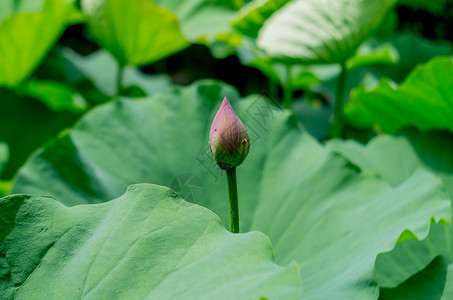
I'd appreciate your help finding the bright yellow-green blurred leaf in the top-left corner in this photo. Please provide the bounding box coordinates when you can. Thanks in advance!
[0,0,74,87]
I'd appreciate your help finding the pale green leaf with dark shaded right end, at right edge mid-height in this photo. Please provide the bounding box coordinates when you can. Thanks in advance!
[328,129,453,193]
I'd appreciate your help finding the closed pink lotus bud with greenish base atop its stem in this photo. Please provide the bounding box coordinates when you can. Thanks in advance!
[209,97,250,170]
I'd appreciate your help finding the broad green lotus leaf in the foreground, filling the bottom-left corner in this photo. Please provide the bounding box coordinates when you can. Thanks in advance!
[0,184,301,299]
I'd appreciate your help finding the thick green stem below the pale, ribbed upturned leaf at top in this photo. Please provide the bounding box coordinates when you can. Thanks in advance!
[330,61,348,138]
